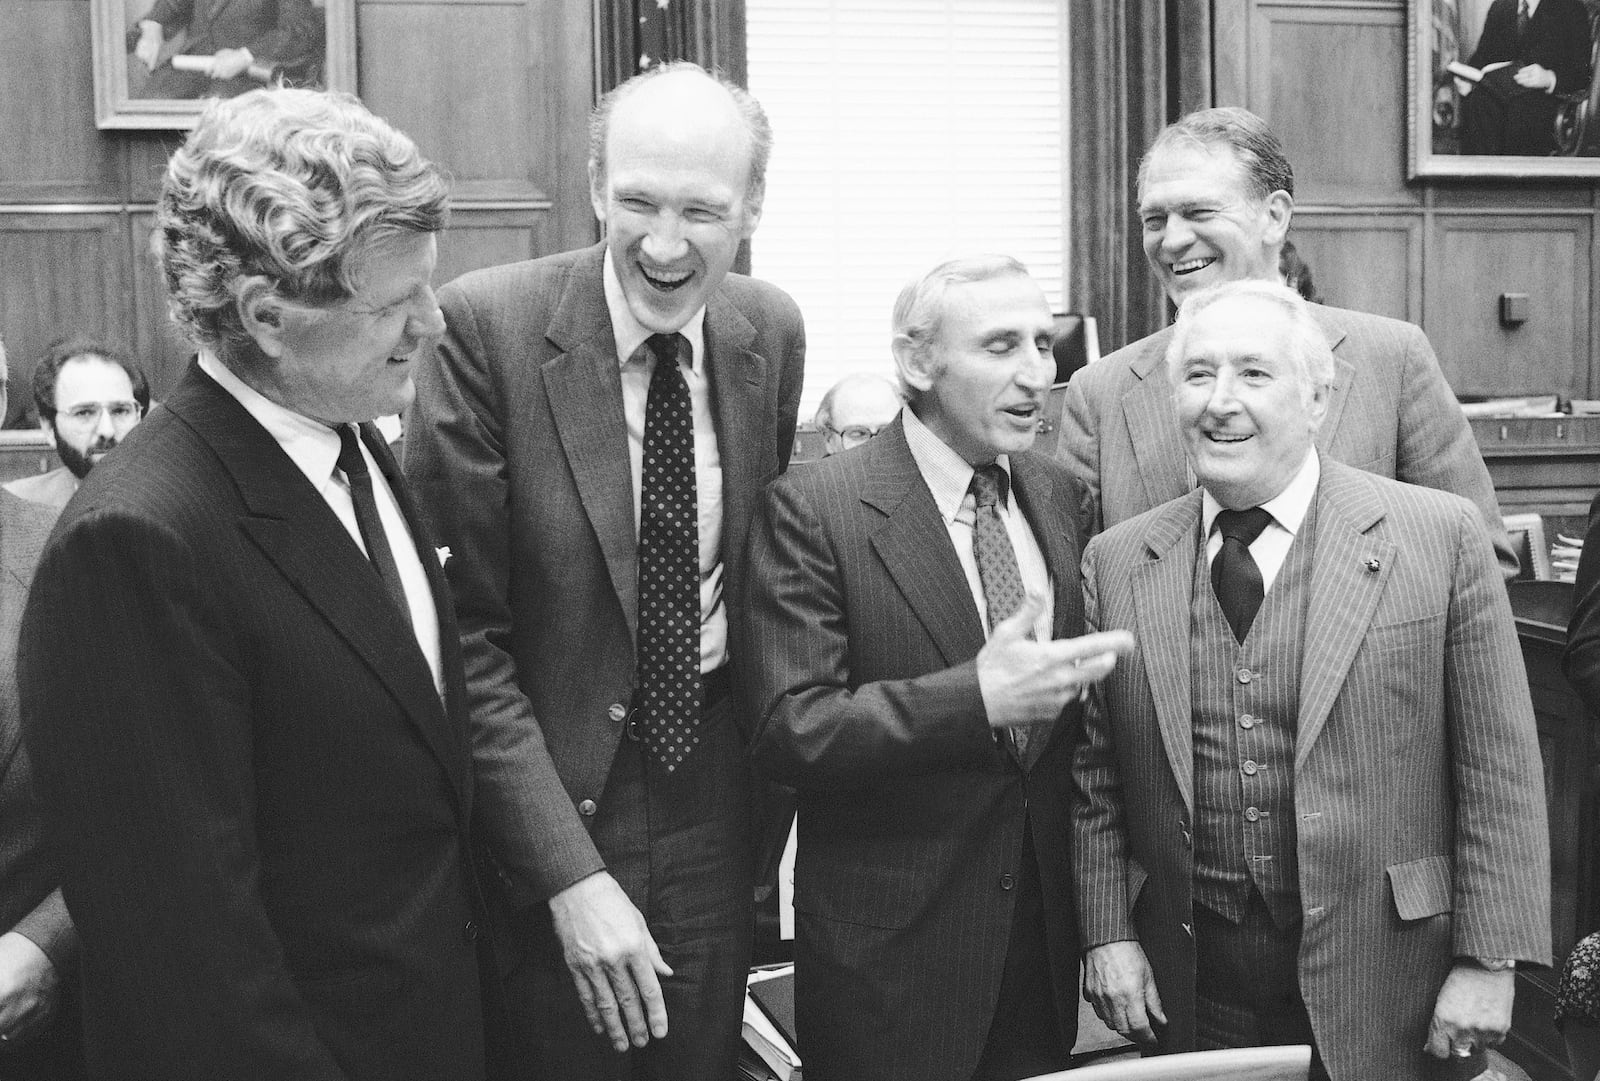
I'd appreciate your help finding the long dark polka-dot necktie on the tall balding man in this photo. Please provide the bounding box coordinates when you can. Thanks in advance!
[638,334,701,772]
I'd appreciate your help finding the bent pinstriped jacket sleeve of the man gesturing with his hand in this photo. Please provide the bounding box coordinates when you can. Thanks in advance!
[739,478,1002,788]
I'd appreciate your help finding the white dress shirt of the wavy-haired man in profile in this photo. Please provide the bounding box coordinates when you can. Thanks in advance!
[200,350,445,696]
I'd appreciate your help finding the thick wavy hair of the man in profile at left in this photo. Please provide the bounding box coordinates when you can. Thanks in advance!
[155,88,450,358]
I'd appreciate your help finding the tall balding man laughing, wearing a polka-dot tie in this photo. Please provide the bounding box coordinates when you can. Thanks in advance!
[406,64,805,1081]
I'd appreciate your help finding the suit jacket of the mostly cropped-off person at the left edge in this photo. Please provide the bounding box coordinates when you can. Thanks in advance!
[0,491,77,979]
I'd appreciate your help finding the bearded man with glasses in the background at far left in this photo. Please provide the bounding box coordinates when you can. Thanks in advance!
[5,337,150,510]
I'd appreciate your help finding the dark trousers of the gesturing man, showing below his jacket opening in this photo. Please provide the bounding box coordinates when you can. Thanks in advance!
[966,825,1077,1081]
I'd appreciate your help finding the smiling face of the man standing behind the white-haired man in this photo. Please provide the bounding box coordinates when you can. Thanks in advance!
[1139,142,1293,305]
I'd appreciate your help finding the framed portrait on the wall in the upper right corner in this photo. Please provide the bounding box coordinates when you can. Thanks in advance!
[1408,0,1600,178]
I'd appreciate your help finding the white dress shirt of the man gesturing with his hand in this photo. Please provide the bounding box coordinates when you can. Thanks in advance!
[901,406,1056,641]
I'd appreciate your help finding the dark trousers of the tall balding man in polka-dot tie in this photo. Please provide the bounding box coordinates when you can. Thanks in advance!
[506,687,754,1081]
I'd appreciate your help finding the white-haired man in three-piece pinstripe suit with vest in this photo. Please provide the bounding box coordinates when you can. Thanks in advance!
[1074,281,1550,1081]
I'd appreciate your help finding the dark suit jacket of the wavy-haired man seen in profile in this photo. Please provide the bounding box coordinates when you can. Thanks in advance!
[19,366,483,1081]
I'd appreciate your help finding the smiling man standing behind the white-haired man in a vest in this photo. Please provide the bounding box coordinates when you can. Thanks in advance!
[1058,109,1517,576]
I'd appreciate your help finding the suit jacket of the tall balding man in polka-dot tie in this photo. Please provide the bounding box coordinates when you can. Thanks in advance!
[406,246,805,903]
